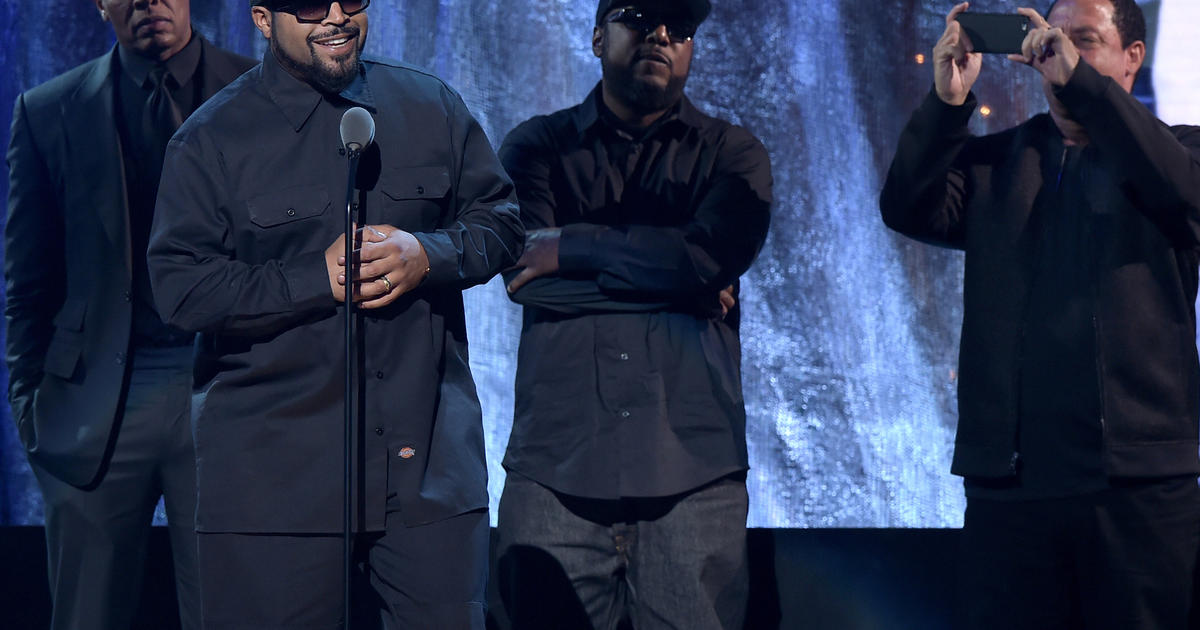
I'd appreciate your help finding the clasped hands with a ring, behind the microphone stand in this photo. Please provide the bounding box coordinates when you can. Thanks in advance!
[325,224,430,308]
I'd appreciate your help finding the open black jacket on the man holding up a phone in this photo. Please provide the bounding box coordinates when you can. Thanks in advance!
[880,61,1200,478]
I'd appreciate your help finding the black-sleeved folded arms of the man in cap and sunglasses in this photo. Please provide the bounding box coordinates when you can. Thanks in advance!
[500,120,772,312]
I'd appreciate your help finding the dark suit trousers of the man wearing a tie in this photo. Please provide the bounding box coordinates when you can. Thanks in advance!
[34,347,199,630]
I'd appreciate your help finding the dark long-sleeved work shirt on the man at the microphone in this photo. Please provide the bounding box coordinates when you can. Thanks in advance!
[149,52,523,533]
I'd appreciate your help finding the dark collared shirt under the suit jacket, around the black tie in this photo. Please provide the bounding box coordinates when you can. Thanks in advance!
[116,35,202,347]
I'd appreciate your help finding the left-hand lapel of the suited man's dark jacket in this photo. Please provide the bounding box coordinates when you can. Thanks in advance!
[62,47,131,268]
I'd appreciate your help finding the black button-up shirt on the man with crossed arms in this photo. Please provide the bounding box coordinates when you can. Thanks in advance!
[500,88,772,499]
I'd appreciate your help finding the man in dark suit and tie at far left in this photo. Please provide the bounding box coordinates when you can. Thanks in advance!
[5,0,253,630]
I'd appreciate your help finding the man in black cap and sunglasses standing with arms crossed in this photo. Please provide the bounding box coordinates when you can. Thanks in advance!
[498,0,772,629]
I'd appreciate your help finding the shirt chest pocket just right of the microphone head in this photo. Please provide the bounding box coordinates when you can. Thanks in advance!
[366,166,450,232]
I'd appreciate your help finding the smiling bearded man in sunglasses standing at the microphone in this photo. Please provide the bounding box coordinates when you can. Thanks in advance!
[149,0,522,629]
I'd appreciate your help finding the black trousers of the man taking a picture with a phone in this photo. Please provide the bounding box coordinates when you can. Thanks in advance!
[955,478,1200,630]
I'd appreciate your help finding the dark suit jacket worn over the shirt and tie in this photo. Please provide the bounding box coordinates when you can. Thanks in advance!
[4,34,256,486]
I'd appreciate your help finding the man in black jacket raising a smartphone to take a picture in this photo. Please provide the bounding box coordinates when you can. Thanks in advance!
[880,0,1200,630]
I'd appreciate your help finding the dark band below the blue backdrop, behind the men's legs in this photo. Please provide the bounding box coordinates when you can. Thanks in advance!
[0,527,959,630]
